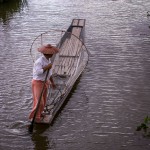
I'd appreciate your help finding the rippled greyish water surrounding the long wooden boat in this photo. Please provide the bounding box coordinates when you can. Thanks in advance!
[0,0,150,150]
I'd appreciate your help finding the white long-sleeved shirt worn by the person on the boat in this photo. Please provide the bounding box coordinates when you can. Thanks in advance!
[33,55,52,81]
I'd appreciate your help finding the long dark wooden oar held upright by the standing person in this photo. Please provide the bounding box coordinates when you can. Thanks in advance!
[28,69,49,133]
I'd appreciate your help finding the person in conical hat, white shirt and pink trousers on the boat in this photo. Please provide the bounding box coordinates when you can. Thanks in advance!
[29,44,59,122]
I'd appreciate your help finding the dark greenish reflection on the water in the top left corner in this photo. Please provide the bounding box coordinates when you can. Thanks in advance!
[0,0,28,24]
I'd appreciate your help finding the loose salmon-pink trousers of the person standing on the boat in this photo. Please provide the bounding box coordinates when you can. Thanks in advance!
[29,80,49,121]
